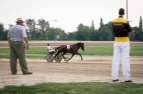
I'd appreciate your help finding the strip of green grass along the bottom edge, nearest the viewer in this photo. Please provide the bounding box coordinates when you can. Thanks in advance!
[0,82,143,94]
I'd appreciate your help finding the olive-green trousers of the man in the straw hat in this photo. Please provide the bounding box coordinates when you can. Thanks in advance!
[10,41,28,74]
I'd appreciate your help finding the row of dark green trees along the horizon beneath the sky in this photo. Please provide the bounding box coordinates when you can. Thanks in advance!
[0,16,143,41]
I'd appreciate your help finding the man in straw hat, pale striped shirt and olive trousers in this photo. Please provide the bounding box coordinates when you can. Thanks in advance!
[7,18,32,75]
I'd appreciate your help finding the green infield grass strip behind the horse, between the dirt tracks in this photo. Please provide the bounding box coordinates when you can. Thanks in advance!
[0,46,143,59]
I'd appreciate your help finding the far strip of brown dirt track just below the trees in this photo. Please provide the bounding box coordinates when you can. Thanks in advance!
[0,41,143,47]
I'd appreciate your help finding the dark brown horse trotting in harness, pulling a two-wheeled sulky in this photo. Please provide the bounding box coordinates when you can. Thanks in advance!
[54,42,84,61]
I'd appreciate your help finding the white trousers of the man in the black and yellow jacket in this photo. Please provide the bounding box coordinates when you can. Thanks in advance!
[111,42,130,81]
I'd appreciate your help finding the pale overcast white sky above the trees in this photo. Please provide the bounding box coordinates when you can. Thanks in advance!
[0,0,143,32]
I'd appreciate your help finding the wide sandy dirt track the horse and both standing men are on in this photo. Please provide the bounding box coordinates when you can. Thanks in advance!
[0,42,143,88]
